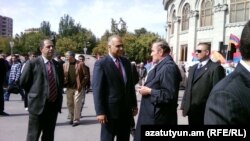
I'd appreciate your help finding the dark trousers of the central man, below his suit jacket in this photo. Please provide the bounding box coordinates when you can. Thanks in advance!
[101,119,131,141]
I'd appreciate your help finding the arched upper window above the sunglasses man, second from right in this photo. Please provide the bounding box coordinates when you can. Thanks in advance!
[200,0,214,27]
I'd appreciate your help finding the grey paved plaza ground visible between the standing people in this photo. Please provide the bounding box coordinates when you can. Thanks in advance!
[0,90,187,141]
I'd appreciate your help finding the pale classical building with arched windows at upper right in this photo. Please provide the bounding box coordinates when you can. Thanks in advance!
[163,0,250,62]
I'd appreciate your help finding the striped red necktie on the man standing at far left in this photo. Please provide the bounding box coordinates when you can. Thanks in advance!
[47,61,57,102]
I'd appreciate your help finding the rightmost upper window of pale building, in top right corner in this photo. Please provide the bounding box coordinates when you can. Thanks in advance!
[230,0,250,23]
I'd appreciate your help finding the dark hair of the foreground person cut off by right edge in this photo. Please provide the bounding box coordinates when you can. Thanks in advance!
[240,20,250,60]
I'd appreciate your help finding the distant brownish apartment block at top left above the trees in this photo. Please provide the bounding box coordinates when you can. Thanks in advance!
[0,15,13,37]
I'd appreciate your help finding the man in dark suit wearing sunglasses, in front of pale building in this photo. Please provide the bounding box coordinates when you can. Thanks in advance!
[181,43,225,125]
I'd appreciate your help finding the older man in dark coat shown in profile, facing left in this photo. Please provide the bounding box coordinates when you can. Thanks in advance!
[135,40,181,141]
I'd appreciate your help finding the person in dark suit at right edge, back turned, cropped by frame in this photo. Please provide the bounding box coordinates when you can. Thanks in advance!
[204,21,250,125]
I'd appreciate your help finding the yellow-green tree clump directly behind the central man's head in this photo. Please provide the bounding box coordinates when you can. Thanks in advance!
[93,19,160,63]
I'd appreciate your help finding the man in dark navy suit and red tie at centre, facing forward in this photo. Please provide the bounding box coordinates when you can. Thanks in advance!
[93,35,137,141]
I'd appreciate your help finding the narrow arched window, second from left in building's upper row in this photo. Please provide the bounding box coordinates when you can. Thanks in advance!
[181,3,190,31]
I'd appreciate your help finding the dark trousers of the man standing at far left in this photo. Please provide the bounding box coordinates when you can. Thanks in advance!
[27,102,58,141]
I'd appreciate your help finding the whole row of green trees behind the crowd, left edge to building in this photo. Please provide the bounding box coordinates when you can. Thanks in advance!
[0,14,160,63]
